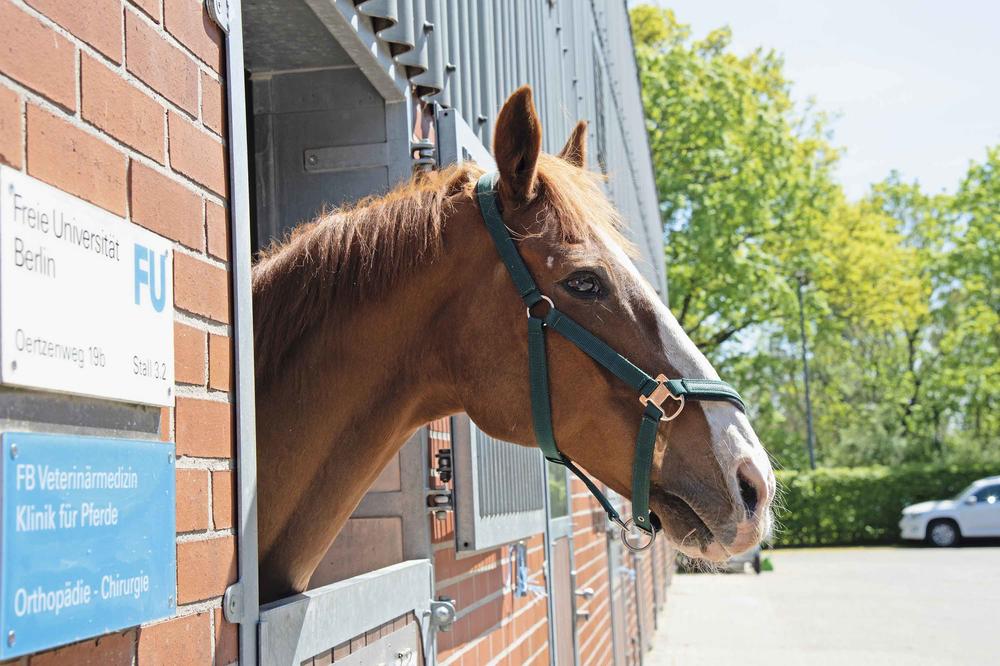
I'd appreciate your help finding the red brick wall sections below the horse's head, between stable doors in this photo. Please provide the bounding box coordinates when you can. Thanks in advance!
[429,419,669,666]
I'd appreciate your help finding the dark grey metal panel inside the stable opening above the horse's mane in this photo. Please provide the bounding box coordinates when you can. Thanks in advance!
[252,68,410,245]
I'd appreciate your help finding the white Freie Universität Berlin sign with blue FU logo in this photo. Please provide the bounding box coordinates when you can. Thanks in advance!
[0,166,174,406]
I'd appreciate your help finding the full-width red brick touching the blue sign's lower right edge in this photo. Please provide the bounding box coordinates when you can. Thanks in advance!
[177,536,236,600]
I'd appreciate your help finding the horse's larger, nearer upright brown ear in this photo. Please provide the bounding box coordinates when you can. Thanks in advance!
[493,86,542,205]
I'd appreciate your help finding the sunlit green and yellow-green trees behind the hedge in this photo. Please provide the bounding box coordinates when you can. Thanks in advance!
[631,5,1000,468]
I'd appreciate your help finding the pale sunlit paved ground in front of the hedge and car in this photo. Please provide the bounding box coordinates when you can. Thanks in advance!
[645,546,1000,666]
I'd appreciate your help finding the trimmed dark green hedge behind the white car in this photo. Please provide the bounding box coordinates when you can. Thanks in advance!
[774,464,1000,547]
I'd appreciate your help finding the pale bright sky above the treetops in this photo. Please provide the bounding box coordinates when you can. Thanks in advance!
[648,0,1000,199]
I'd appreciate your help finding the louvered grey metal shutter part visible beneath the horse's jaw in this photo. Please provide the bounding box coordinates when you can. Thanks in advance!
[451,416,546,551]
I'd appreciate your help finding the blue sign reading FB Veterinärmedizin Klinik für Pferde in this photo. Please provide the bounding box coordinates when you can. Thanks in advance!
[0,432,177,659]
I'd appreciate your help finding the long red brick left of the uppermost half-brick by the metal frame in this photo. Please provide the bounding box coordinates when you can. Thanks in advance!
[125,11,198,116]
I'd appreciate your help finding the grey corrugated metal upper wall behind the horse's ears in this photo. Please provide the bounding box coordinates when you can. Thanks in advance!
[344,0,665,295]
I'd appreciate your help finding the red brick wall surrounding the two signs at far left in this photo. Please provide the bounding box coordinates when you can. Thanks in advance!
[0,0,237,666]
